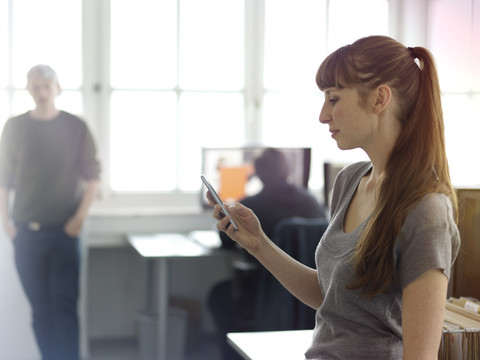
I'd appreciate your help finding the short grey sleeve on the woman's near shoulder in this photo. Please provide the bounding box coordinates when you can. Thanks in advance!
[395,194,460,288]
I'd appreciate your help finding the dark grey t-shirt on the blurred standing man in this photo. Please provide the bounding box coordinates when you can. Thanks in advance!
[0,111,100,224]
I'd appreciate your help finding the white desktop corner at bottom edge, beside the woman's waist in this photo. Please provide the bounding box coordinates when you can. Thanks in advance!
[227,330,313,360]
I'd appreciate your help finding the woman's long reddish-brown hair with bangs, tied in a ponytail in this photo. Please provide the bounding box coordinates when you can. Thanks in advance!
[316,36,458,296]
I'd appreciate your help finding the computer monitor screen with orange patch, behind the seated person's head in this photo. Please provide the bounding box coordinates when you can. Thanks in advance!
[201,146,311,207]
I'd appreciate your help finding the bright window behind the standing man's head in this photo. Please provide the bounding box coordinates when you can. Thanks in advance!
[0,0,83,126]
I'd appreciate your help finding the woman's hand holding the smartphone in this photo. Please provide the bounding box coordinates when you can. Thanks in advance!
[207,191,268,255]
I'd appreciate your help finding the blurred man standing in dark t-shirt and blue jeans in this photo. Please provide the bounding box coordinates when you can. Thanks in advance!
[0,65,100,360]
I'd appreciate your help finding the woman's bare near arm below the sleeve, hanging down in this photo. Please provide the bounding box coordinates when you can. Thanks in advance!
[402,269,448,360]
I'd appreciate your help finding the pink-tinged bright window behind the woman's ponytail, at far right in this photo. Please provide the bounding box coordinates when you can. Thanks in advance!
[428,0,480,186]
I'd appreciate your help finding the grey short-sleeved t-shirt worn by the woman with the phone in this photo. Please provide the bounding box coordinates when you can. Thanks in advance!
[305,162,460,360]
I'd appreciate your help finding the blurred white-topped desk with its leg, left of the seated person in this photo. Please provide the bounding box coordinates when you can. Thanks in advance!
[128,232,232,360]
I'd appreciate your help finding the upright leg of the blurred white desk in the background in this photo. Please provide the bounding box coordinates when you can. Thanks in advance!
[157,258,170,360]
